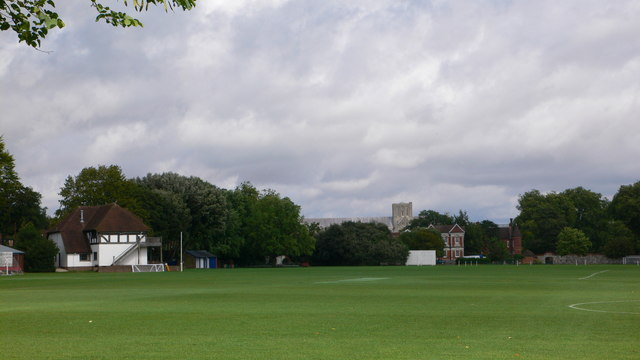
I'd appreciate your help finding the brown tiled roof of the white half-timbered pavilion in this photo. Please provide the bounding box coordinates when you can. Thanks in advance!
[47,203,149,254]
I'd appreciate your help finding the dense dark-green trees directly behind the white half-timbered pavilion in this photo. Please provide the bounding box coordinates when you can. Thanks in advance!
[56,165,315,264]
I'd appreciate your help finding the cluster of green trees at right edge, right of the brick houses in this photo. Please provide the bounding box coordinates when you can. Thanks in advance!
[516,187,640,258]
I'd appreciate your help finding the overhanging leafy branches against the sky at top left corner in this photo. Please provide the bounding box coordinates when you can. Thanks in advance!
[0,0,196,48]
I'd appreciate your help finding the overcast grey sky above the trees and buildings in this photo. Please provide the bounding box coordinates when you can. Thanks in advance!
[0,0,640,223]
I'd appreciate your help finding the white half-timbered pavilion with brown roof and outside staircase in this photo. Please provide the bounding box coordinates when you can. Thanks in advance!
[47,204,162,270]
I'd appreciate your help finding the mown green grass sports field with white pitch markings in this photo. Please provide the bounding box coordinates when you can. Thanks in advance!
[0,265,640,359]
